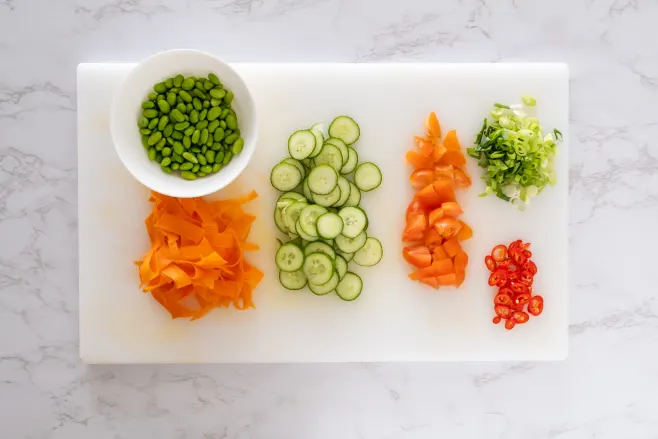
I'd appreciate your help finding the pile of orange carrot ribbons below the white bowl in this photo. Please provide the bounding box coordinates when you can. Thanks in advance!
[136,192,263,320]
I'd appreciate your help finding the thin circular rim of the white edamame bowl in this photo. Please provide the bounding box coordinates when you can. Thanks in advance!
[109,49,258,198]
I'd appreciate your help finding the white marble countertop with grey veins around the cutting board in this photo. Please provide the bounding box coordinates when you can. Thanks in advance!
[0,0,658,439]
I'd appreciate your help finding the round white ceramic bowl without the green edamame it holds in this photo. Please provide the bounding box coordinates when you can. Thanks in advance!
[110,50,258,198]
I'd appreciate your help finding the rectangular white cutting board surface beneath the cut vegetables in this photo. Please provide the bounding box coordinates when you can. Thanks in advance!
[78,64,568,363]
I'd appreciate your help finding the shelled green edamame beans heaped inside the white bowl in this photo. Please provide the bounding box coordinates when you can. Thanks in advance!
[137,73,244,180]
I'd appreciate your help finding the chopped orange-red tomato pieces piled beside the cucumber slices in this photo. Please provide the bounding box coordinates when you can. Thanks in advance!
[402,113,473,288]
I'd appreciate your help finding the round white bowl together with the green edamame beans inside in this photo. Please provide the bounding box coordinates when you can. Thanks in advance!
[110,50,258,198]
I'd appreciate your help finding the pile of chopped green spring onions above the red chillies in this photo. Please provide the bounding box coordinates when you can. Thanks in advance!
[467,95,562,210]
